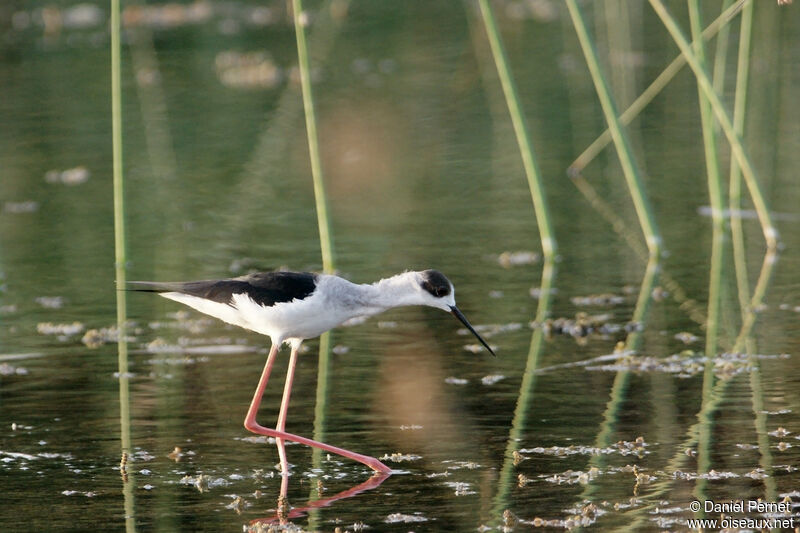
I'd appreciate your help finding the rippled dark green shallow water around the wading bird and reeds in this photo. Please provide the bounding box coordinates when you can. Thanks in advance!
[0,1,800,531]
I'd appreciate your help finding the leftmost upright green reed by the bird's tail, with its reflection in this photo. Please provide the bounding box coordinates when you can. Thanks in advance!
[111,0,136,532]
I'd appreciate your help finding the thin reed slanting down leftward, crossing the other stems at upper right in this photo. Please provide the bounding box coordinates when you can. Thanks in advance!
[569,2,741,172]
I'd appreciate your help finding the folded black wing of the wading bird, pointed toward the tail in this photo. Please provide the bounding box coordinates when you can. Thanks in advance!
[129,272,317,307]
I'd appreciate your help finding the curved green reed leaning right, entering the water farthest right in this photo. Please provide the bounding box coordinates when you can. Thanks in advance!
[650,0,778,249]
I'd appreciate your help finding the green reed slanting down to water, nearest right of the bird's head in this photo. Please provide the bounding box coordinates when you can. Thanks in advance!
[478,0,557,258]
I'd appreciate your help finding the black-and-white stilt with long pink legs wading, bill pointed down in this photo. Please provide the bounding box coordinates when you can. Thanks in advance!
[128,270,495,475]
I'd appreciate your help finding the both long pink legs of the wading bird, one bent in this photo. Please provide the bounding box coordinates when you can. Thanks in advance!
[244,345,392,474]
